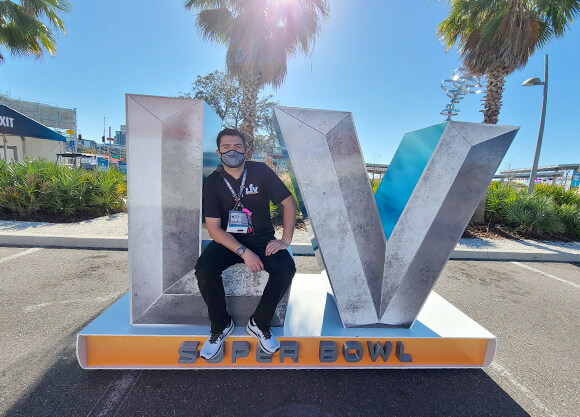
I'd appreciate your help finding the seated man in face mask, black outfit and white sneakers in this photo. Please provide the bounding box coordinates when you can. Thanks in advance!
[195,129,296,359]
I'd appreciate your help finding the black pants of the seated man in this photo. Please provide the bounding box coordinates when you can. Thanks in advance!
[195,236,296,333]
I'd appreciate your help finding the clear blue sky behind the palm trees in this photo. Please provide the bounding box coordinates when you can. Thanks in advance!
[0,0,580,169]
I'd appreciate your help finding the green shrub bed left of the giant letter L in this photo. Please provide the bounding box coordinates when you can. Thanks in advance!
[0,158,127,220]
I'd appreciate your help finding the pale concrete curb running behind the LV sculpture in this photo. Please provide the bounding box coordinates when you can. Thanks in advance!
[0,233,580,262]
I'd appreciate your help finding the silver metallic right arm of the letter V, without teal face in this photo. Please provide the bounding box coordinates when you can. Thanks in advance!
[381,122,517,327]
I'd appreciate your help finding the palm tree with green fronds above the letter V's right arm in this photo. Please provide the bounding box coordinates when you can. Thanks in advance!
[437,0,580,124]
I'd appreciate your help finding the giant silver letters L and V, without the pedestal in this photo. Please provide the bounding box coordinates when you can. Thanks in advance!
[127,95,517,327]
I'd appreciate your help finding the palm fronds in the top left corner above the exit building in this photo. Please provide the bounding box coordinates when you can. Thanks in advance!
[0,0,71,64]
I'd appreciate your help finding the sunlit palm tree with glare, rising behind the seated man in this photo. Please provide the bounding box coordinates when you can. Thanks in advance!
[185,0,329,155]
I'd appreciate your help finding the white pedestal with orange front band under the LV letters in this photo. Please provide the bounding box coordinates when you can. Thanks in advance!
[77,274,496,369]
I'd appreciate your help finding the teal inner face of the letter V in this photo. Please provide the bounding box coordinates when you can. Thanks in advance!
[375,122,447,240]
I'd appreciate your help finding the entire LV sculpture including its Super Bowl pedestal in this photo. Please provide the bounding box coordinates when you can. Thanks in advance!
[77,94,517,369]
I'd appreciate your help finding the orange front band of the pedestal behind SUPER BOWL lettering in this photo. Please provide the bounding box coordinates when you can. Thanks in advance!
[79,335,489,369]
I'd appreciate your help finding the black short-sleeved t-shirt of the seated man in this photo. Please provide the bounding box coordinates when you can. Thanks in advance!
[203,161,291,237]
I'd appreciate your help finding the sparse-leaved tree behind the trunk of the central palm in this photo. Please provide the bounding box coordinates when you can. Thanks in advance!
[180,71,278,155]
